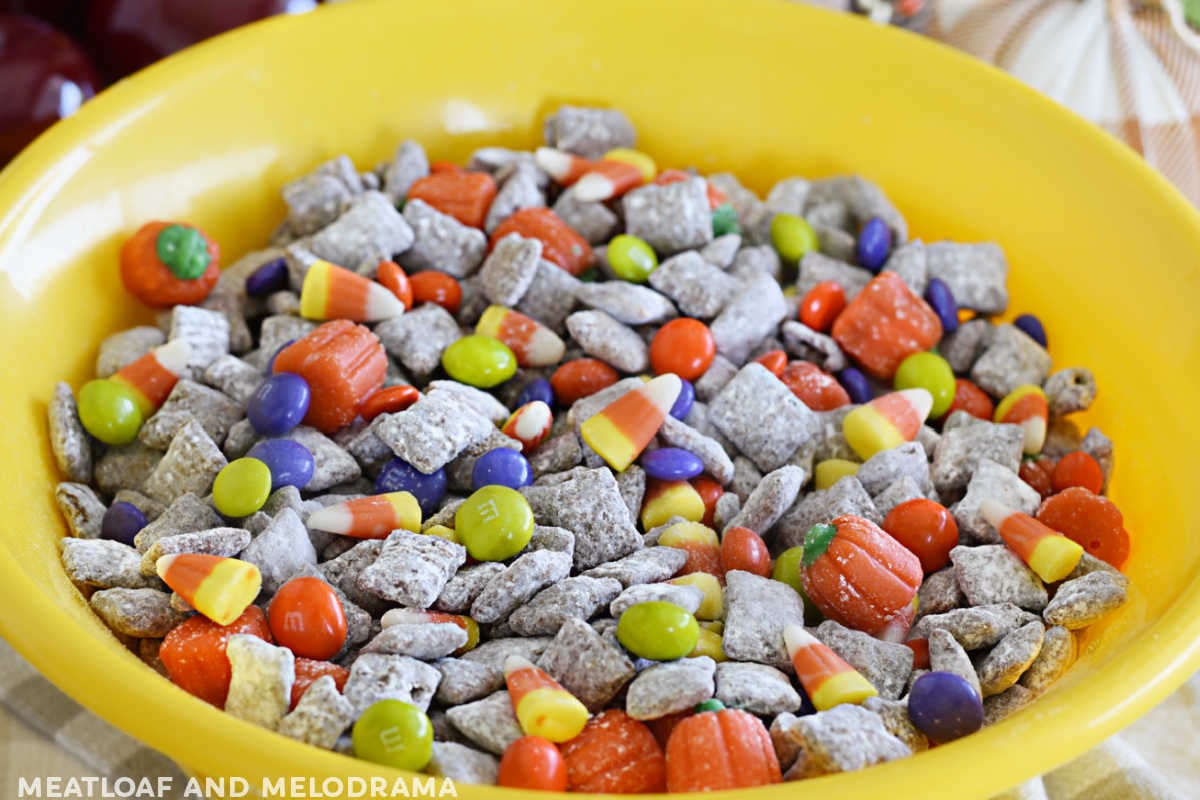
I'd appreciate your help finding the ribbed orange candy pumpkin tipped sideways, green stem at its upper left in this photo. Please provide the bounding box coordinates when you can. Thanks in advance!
[800,515,922,638]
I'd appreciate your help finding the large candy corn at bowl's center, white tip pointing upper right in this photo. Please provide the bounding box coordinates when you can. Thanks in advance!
[580,373,686,472]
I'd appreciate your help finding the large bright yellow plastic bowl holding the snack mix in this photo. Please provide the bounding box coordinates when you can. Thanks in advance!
[0,0,1200,800]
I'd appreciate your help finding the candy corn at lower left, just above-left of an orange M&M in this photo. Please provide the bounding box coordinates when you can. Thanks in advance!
[155,553,263,625]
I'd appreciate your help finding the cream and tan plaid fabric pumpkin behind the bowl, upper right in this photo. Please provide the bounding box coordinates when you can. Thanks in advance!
[929,0,1200,205]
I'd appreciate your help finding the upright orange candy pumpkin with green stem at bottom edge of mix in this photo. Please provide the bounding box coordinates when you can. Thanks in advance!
[667,700,784,792]
